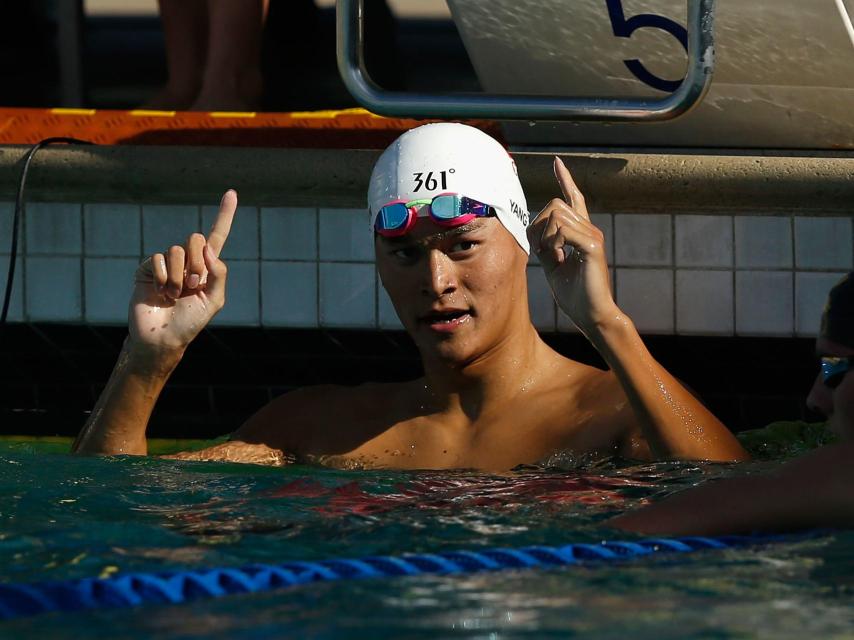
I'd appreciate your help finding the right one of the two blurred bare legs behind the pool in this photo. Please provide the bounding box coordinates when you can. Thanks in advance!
[192,0,267,111]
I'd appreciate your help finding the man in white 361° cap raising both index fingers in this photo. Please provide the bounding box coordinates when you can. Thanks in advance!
[73,123,747,470]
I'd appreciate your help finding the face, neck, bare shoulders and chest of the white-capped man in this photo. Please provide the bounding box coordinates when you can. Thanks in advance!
[227,218,649,469]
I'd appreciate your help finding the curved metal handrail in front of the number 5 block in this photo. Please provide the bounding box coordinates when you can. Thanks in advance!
[336,0,715,122]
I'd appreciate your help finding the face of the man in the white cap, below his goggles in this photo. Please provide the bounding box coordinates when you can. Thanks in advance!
[375,218,530,366]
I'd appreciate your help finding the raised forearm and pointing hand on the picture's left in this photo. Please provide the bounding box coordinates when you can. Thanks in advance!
[72,190,237,455]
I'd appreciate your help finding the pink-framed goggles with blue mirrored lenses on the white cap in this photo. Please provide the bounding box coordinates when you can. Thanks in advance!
[374,193,495,238]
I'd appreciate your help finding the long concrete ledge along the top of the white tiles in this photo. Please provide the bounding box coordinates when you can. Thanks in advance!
[0,146,854,216]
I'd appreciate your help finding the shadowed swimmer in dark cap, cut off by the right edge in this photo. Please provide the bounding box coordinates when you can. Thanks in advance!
[609,272,854,535]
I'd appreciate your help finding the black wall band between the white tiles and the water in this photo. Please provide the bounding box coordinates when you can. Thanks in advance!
[0,324,818,438]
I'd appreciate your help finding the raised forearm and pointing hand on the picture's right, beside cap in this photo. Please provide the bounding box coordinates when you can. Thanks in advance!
[528,158,748,460]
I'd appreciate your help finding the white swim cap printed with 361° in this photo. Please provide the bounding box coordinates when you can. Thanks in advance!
[368,122,530,253]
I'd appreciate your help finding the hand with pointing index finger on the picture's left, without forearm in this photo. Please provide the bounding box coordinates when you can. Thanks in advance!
[128,189,237,351]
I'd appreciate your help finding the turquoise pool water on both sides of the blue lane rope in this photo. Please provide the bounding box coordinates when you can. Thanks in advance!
[0,441,854,639]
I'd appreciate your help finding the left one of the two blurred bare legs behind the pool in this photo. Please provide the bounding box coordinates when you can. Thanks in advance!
[144,0,209,110]
